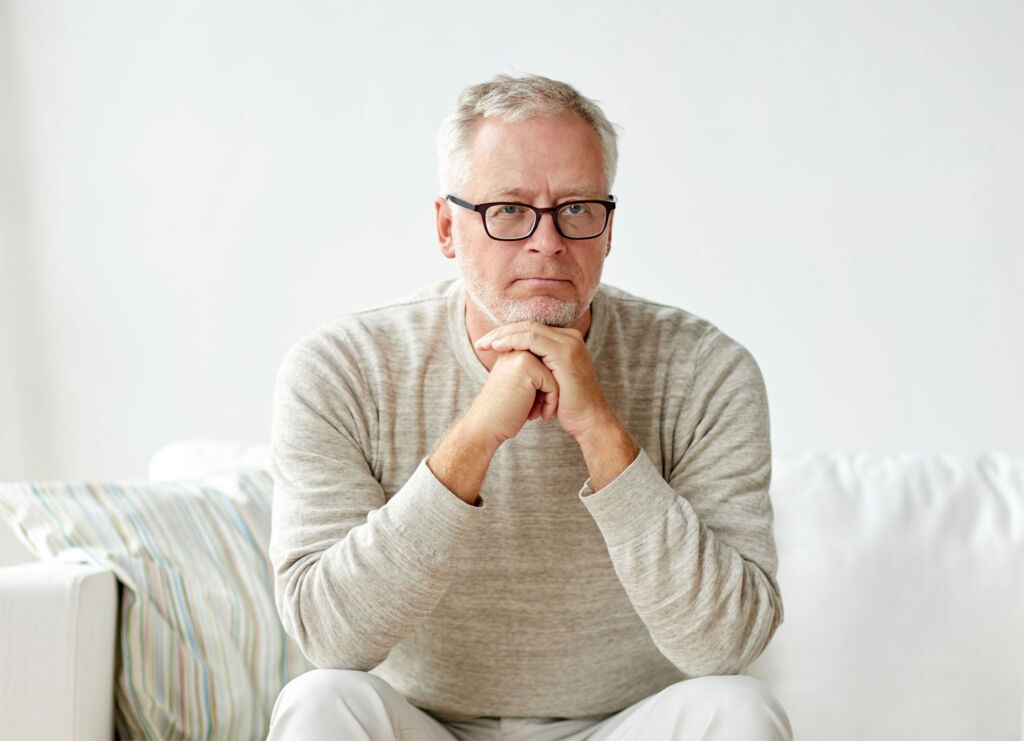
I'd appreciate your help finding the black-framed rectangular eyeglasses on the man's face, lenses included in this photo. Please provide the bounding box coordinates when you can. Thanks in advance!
[444,193,615,242]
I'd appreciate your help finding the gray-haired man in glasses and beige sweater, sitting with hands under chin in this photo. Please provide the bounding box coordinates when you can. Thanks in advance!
[270,76,790,739]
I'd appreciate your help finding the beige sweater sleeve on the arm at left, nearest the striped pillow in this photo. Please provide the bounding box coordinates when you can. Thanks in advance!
[270,337,480,670]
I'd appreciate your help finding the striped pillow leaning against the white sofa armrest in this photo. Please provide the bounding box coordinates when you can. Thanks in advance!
[0,471,307,739]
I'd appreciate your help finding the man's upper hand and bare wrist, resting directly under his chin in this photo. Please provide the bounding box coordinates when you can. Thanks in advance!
[476,321,640,489]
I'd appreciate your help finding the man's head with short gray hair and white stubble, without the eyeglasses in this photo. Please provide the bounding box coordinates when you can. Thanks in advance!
[436,76,616,332]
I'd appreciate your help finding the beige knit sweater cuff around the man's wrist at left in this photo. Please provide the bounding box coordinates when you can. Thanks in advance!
[377,460,484,555]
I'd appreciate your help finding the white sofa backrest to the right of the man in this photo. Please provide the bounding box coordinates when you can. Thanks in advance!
[751,453,1024,741]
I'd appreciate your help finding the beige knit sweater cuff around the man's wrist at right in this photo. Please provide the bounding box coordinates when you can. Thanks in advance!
[580,449,679,546]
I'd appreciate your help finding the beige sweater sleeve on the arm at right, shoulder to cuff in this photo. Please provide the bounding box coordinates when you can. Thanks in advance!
[581,328,782,677]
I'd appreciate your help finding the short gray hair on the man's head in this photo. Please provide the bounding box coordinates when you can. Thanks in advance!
[437,75,618,193]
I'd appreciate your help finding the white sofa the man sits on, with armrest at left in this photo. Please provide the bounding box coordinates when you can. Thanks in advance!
[0,443,1024,741]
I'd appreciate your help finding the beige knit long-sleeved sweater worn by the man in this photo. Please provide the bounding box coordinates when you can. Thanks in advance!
[270,280,782,720]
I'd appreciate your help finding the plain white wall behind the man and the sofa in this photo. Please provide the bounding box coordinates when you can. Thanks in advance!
[0,0,1024,479]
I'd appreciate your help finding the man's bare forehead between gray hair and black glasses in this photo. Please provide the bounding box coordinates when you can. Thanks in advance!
[469,114,607,198]
